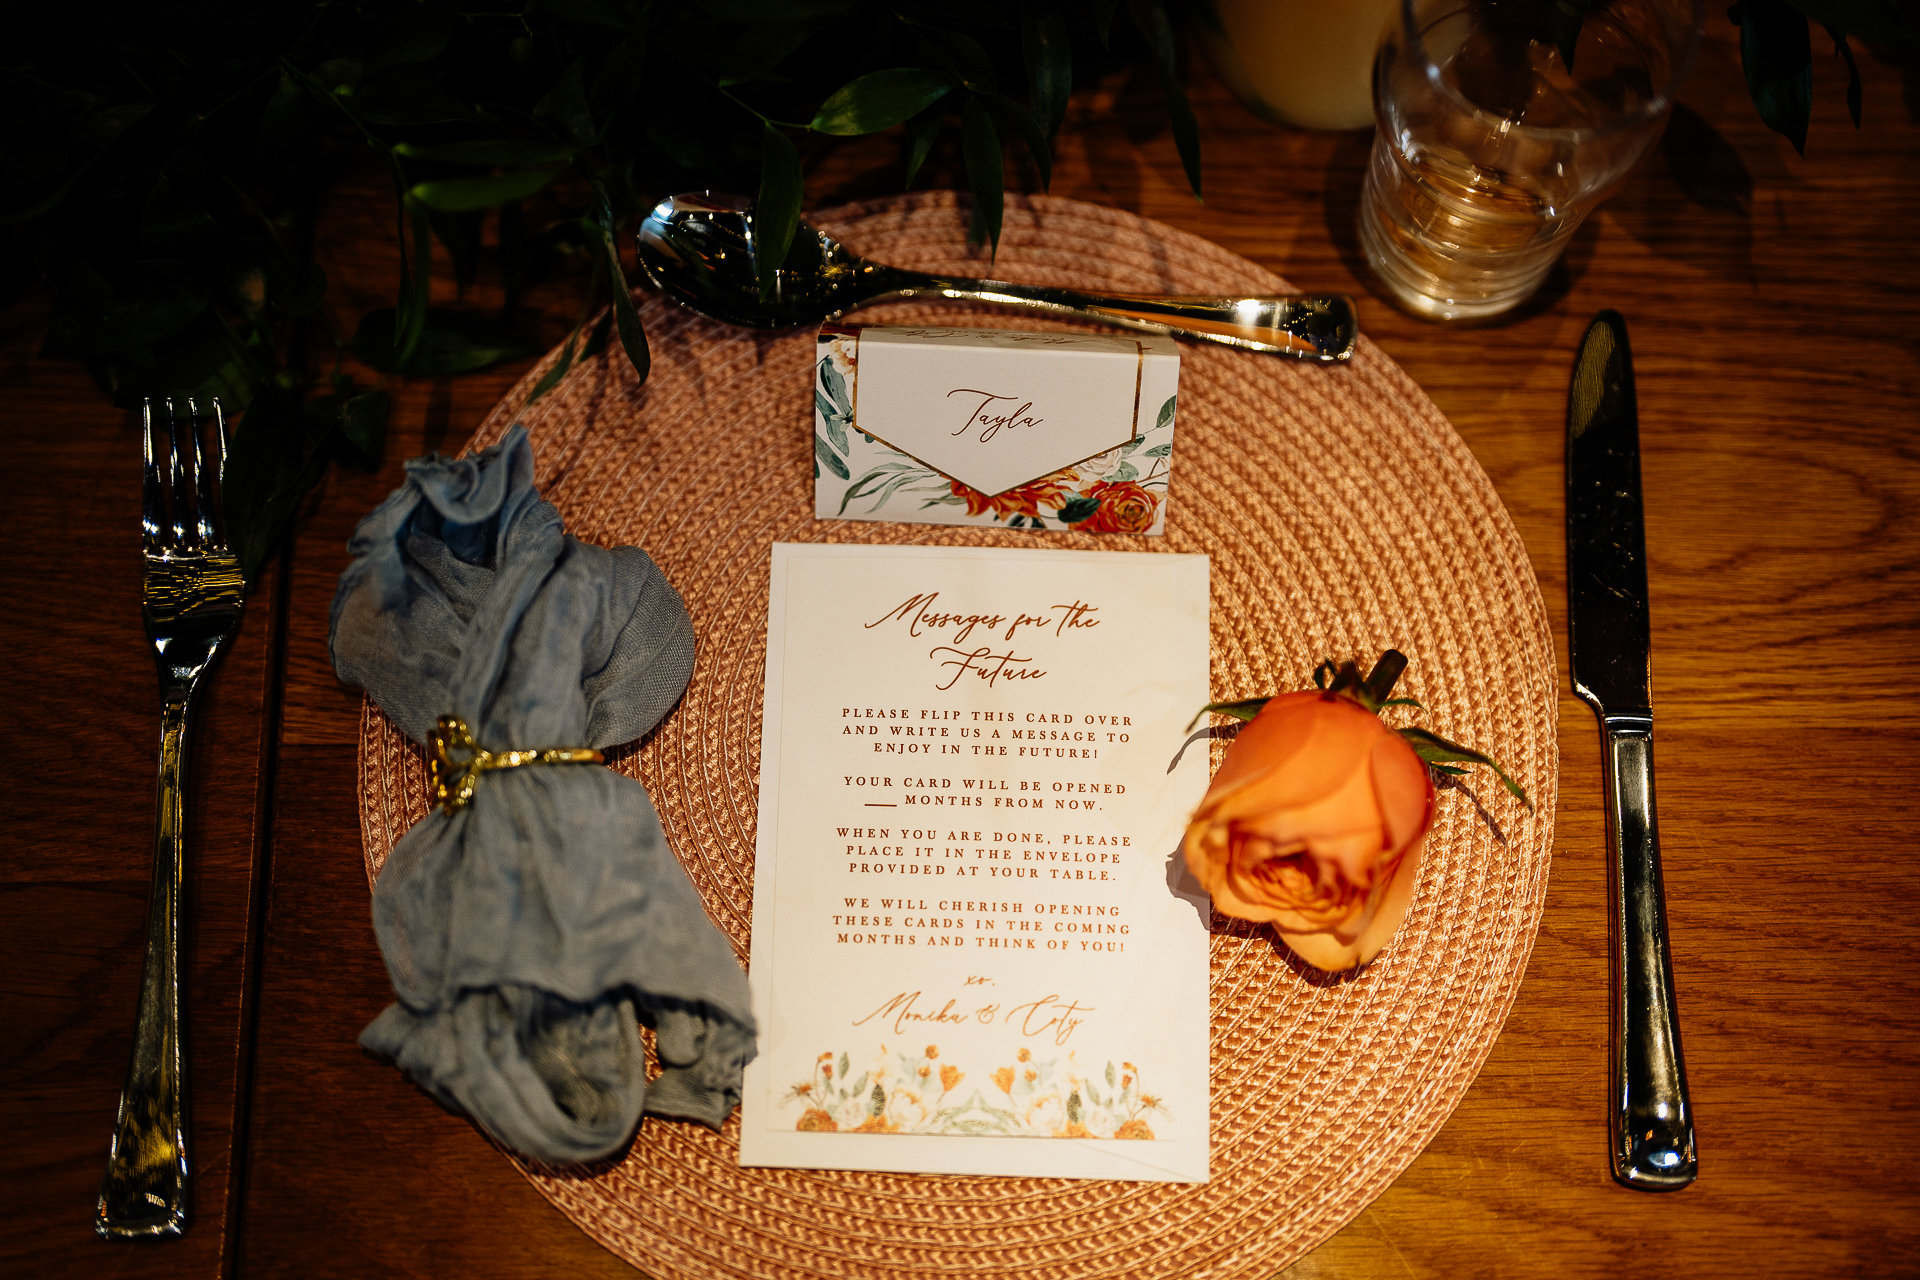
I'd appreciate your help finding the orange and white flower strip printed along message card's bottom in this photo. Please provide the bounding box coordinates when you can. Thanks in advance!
[781,1044,1167,1142]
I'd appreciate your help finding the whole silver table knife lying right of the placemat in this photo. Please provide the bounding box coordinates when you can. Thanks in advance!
[1567,311,1699,1192]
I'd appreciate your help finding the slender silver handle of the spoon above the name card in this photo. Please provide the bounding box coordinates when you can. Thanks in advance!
[868,271,1359,363]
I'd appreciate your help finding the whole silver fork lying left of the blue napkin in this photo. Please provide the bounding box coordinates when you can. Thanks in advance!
[94,399,242,1240]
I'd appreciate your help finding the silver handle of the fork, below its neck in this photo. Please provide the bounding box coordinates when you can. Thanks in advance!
[94,699,188,1240]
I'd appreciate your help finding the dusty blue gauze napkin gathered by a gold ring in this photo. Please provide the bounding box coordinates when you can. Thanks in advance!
[330,426,755,1161]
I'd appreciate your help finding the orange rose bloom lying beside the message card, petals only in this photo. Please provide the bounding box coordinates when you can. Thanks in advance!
[1183,691,1434,971]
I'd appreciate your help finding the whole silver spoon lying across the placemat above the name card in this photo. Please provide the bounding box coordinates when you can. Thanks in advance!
[639,192,1359,361]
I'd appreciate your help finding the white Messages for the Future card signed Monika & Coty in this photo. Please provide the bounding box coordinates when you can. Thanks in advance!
[741,545,1208,1182]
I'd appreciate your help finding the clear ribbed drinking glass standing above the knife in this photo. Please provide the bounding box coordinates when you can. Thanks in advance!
[1359,0,1701,320]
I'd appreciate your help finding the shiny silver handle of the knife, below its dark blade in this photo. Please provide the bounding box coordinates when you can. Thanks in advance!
[1601,716,1699,1192]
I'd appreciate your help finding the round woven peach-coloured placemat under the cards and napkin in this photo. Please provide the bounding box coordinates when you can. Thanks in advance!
[361,194,1557,1280]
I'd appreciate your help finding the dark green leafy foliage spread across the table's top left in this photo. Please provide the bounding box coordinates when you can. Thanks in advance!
[0,0,1200,574]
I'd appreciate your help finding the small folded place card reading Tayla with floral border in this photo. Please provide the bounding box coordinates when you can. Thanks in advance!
[814,324,1181,535]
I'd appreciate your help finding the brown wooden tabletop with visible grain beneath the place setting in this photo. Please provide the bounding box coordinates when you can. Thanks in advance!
[0,15,1920,1278]
